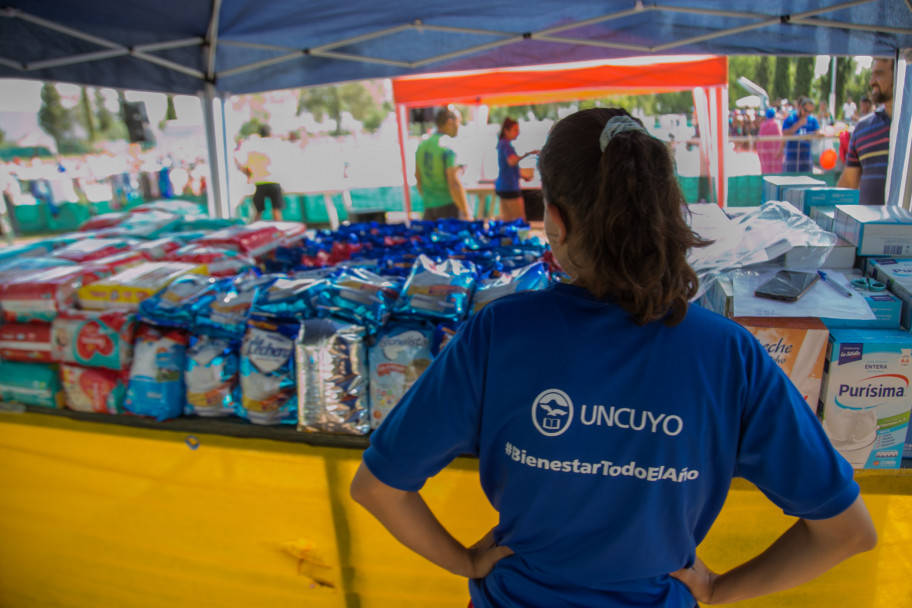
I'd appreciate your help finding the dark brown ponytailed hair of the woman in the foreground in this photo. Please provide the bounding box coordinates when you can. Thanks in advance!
[538,108,709,325]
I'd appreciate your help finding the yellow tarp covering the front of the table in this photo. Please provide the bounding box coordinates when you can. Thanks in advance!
[0,413,912,608]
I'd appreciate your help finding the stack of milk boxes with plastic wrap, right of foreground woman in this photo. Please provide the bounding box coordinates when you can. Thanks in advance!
[697,200,912,469]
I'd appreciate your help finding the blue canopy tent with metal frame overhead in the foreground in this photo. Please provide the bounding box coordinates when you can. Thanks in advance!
[0,0,912,215]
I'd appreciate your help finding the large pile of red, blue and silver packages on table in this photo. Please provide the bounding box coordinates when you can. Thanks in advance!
[0,216,560,435]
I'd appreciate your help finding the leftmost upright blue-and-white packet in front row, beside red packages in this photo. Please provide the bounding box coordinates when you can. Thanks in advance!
[124,324,187,420]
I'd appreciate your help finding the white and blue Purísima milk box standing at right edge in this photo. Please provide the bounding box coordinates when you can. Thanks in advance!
[817,329,912,469]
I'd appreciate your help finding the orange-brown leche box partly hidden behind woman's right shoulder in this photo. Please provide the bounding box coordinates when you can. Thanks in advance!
[735,317,830,410]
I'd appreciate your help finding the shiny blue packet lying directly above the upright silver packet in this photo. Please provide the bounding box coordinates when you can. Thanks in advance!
[316,268,402,333]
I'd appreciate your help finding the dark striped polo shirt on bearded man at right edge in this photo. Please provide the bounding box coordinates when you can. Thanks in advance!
[846,110,890,205]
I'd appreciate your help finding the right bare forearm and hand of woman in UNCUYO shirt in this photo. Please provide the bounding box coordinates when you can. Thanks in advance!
[671,496,877,604]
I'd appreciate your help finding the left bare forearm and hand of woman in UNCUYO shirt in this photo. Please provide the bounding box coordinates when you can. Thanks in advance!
[351,462,513,578]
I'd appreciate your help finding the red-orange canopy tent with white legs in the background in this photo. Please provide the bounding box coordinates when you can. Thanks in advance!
[393,56,728,211]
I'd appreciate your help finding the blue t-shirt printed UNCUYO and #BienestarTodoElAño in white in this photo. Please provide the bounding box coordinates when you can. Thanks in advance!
[364,284,858,608]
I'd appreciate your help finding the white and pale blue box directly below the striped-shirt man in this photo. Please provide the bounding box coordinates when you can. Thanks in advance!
[834,205,912,257]
